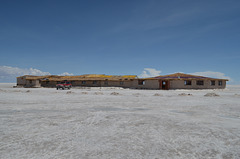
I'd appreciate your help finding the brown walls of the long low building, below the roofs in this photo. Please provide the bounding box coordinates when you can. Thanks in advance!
[17,76,226,89]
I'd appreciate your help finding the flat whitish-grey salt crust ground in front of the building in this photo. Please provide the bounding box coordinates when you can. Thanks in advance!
[0,84,240,159]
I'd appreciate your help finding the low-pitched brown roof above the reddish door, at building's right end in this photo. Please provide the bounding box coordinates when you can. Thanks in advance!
[144,73,228,81]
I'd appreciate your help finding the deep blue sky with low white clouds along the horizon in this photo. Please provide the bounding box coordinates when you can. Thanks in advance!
[0,0,240,84]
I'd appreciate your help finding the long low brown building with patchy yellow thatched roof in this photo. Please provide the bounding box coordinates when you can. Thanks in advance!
[17,73,228,90]
